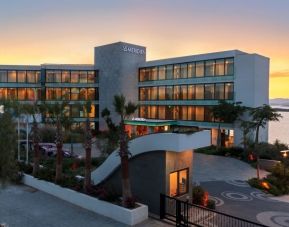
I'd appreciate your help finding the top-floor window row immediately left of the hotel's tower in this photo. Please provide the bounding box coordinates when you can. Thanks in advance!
[46,70,98,83]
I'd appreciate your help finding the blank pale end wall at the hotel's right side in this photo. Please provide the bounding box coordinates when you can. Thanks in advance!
[234,54,269,145]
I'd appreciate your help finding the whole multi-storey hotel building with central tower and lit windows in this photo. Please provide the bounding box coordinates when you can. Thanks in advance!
[0,42,269,145]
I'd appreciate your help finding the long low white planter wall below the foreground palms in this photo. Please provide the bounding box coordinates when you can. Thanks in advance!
[23,174,148,226]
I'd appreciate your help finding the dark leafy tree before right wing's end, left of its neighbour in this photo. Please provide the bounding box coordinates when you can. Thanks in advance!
[212,100,246,148]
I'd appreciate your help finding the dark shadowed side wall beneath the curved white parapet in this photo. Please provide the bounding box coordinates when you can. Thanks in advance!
[104,151,166,214]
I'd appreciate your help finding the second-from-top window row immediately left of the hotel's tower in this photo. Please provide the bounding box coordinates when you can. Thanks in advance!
[46,88,98,101]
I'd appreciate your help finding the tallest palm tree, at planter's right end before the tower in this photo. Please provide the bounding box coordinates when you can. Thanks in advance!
[113,95,137,206]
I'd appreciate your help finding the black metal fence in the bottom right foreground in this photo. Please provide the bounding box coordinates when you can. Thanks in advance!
[160,194,268,227]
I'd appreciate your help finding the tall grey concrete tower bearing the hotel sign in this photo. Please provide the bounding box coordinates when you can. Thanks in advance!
[94,42,146,130]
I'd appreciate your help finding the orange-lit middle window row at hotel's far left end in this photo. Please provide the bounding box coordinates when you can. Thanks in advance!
[0,88,41,101]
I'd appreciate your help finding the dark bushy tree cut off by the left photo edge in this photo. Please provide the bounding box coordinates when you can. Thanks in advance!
[0,109,18,186]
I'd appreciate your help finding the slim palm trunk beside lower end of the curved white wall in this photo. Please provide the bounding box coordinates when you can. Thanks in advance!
[83,102,92,193]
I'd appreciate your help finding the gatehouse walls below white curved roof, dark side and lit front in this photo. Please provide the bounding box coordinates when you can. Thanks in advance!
[104,150,193,214]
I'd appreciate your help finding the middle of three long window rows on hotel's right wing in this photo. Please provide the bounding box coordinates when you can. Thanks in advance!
[139,83,234,101]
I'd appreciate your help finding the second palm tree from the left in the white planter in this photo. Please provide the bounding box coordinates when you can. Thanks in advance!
[42,101,71,183]
